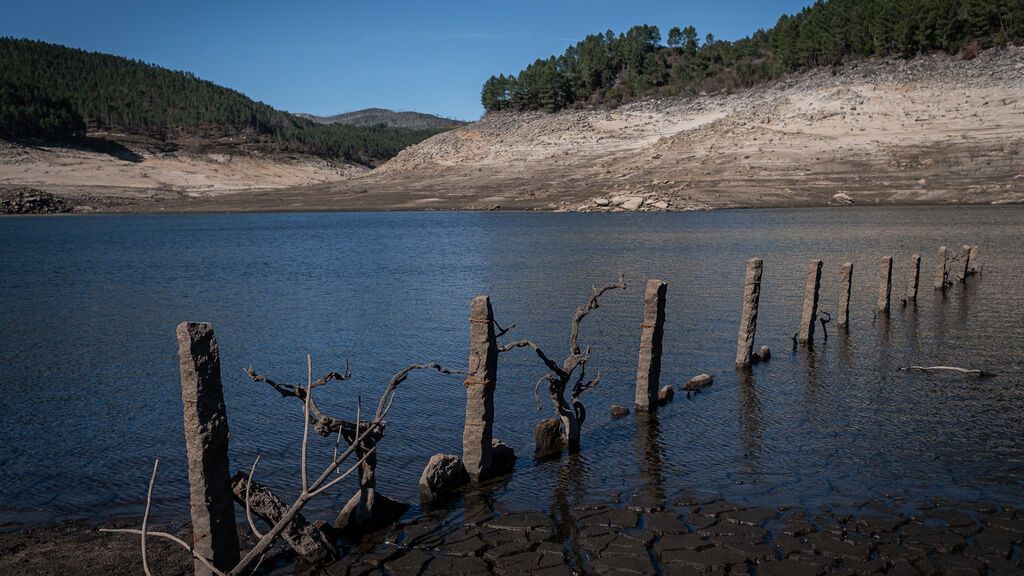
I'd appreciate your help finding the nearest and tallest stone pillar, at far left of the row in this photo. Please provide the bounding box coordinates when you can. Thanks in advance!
[177,322,239,576]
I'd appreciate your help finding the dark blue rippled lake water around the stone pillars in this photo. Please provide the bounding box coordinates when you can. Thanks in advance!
[0,207,1024,523]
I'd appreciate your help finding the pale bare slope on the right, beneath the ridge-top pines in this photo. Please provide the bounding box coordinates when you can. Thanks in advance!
[321,44,1024,210]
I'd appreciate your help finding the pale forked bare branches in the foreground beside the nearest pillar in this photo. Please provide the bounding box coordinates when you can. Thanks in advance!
[100,358,464,576]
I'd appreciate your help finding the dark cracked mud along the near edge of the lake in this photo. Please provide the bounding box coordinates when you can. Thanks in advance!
[0,495,1024,576]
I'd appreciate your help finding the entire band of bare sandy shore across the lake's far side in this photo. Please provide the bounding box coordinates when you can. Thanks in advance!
[0,44,1024,210]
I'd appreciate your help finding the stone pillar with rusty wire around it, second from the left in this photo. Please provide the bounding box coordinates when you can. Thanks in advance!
[462,296,498,482]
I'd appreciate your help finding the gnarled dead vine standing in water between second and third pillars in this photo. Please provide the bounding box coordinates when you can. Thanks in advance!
[499,275,626,452]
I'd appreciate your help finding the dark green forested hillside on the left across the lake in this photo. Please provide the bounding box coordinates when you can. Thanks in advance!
[0,38,440,163]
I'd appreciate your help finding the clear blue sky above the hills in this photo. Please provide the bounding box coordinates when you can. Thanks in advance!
[0,0,812,120]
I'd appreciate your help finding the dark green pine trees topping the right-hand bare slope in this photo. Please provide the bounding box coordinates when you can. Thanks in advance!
[481,0,1024,112]
